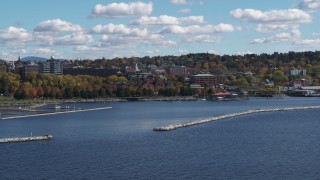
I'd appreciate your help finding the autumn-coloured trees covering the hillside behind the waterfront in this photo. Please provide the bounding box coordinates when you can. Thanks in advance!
[0,51,320,99]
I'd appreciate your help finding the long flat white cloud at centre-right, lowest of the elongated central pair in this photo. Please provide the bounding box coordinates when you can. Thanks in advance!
[161,23,240,34]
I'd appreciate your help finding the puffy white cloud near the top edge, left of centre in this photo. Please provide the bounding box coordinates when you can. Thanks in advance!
[91,2,153,18]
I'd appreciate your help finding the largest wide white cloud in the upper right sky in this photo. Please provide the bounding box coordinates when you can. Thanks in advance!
[230,9,312,23]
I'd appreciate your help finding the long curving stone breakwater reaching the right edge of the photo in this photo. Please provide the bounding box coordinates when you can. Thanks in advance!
[153,106,320,131]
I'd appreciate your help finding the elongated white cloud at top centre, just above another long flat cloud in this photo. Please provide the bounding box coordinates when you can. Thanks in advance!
[131,15,204,25]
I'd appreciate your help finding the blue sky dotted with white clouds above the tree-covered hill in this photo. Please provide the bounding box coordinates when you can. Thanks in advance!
[0,0,320,60]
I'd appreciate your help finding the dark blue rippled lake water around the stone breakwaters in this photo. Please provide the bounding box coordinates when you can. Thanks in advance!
[0,98,320,179]
